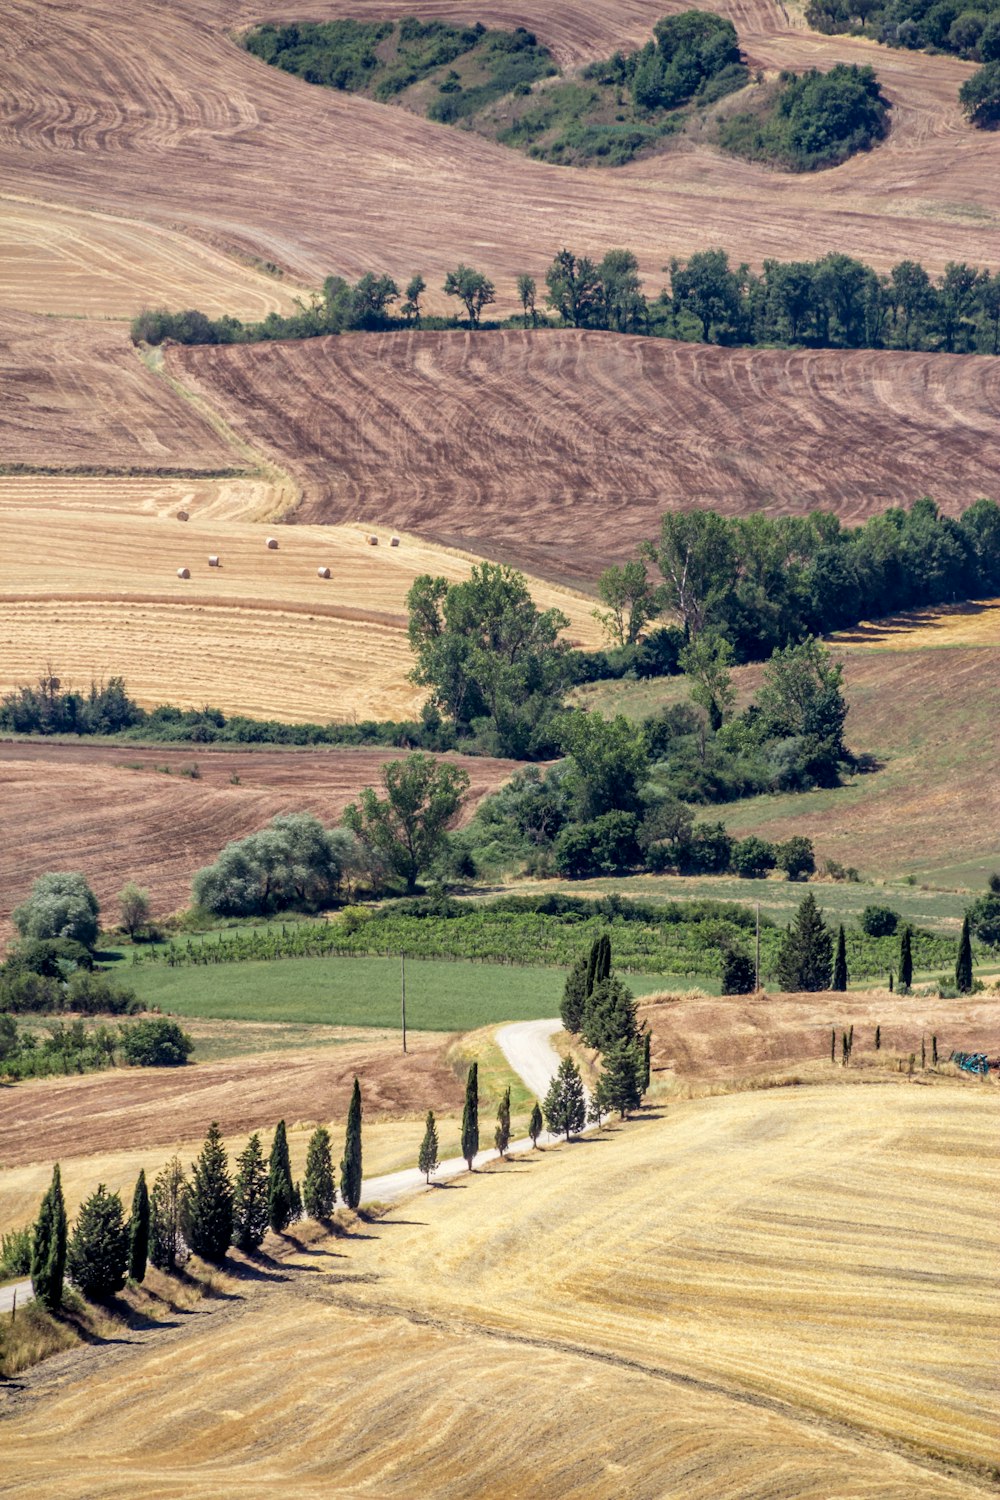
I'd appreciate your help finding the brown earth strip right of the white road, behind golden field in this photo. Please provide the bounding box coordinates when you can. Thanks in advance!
[639,990,1000,1083]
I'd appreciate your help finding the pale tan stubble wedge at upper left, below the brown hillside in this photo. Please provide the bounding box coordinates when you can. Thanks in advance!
[0,195,301,320]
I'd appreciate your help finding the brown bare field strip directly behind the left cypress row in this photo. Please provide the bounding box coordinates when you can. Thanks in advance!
[0,1034,463,1169]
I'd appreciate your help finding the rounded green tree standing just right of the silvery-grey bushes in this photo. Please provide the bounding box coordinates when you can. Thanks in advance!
[343,752,469,891]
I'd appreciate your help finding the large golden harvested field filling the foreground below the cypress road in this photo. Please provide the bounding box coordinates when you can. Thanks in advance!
[3,1085,1000,1500]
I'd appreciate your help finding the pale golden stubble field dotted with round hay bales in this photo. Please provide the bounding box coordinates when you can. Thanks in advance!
[0,504,593,723]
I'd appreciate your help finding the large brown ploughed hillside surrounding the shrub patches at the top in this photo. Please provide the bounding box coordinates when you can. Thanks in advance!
[0,0,1000,305]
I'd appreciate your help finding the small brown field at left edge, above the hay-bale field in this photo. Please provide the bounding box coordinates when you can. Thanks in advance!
[0,311,238,473]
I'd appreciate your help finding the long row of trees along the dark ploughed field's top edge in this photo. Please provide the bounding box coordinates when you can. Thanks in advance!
[132,243,1000,354]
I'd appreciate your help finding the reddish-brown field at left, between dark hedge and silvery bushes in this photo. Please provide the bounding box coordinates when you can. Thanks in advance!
[0,741,516,930]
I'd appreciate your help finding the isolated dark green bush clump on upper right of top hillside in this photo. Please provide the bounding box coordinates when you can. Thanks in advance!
[718,63,892,173]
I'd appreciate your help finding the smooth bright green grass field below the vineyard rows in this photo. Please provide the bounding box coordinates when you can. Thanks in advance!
[121,959,712,1032]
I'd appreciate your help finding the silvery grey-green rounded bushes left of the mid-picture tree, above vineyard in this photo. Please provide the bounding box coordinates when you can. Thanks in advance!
[192,813,354,917]
